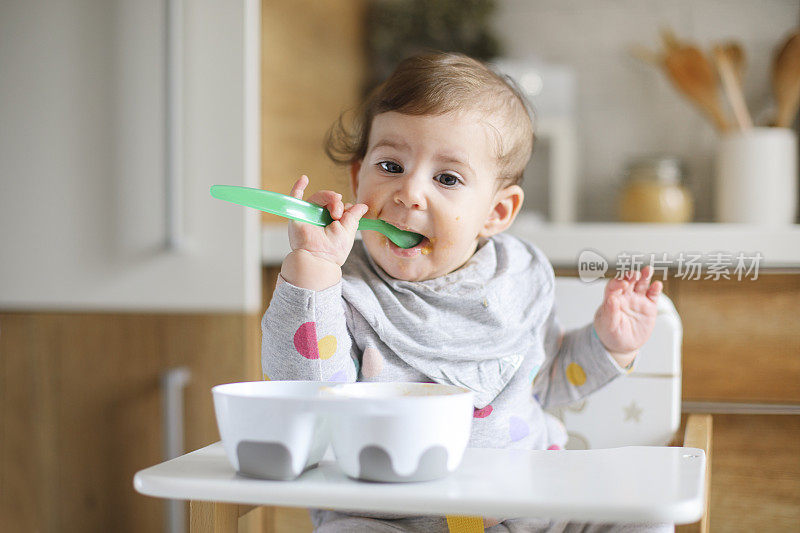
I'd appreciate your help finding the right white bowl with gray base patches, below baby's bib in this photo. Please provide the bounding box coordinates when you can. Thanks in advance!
[323,383,473,482]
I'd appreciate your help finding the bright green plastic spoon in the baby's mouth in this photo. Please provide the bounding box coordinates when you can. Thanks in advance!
[211,185,423,248]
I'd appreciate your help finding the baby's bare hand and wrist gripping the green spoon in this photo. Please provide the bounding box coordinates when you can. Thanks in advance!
[281,176,367,290]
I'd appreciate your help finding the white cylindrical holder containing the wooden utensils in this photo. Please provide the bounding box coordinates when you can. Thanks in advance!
[715,128,797,226]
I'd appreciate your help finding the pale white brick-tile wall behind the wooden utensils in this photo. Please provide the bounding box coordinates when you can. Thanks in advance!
[496,0,800,221]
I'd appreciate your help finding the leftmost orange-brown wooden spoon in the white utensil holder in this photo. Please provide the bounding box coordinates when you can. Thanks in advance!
[661,29,730,131]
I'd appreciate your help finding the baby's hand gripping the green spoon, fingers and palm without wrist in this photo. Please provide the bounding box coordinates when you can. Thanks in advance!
[289,175,368,267]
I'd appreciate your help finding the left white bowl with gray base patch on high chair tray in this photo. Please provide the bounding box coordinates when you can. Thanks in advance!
[211,381,330,479]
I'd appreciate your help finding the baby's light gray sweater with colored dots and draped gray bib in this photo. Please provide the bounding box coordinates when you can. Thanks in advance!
[261,234,626,449]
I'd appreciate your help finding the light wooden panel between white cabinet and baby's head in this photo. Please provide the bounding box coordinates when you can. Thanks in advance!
[261,0,366,222]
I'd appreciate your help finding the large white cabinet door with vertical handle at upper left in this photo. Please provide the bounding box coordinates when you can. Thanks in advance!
[0,0,260,310]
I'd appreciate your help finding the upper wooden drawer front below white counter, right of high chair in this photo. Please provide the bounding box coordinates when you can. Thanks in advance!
[671,272,800,403]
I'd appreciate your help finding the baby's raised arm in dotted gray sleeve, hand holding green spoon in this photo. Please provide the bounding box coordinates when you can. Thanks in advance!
[261,176,367,381]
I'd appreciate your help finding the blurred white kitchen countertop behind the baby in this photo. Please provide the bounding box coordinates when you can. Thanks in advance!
[261,215,800,268]
